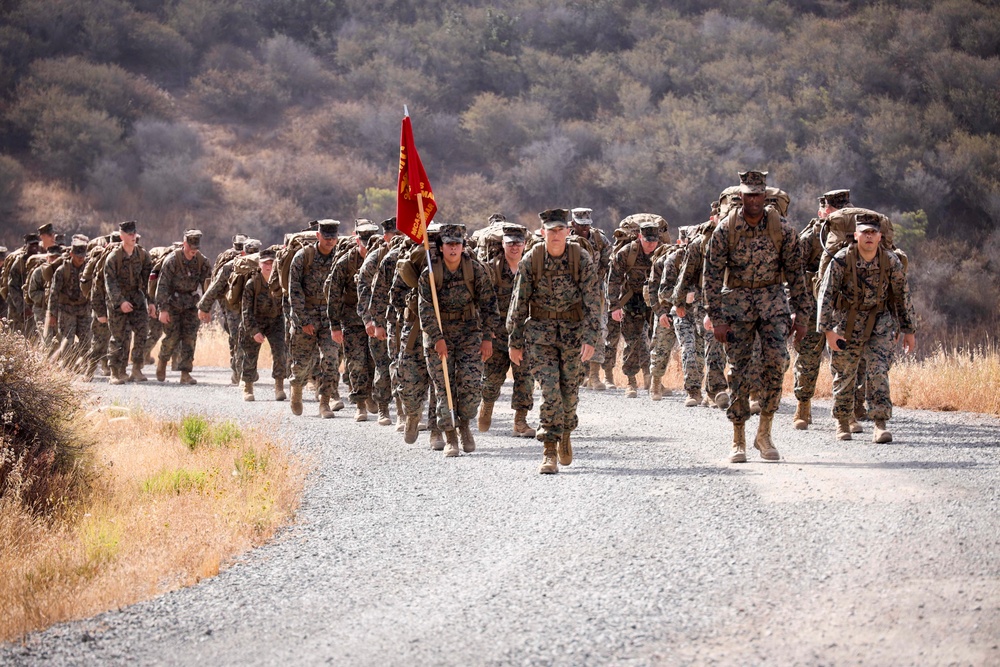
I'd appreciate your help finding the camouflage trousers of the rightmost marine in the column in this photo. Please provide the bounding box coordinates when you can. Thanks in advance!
[830,315,894,419]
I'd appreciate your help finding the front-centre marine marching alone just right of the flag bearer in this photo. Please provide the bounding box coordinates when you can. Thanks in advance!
[507,209,601,474]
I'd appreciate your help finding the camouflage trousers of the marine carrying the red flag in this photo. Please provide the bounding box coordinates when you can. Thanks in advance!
[424,321,483,431]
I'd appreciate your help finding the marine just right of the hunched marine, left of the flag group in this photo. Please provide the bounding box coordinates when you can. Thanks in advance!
[288,220,344,419]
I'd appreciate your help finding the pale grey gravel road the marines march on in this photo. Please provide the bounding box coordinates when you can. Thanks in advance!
[0,369,1000,666]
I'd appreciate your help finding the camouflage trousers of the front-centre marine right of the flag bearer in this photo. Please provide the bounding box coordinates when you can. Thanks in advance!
[524,327,587,442]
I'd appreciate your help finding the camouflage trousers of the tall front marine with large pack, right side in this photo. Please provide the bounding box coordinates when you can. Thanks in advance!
[725,317,791,424]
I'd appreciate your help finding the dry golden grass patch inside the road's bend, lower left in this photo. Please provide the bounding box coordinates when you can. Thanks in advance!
[0,407,304,641]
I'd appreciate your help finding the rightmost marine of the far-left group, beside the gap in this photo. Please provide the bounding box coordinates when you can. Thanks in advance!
[153,229,212,384]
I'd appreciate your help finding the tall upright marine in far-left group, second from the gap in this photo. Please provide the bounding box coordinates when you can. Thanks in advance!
[104,220,153,384]
